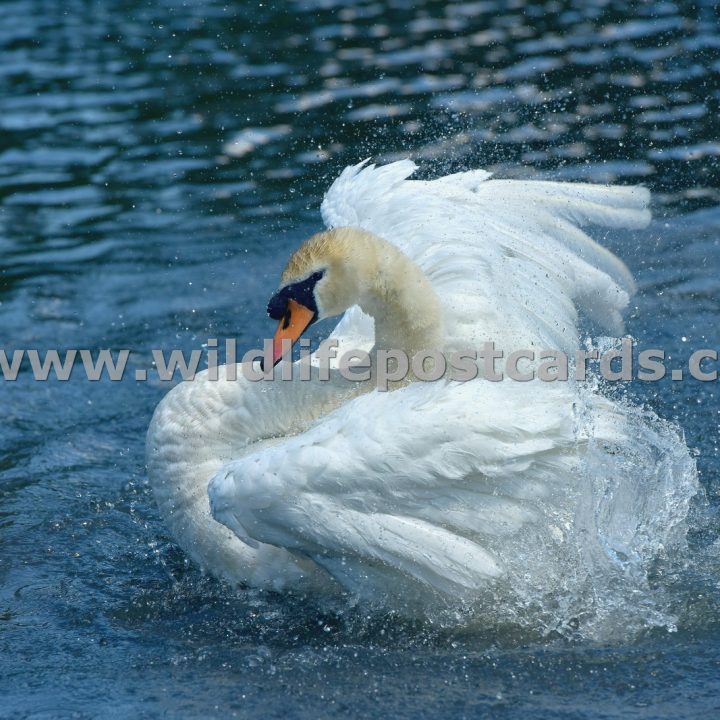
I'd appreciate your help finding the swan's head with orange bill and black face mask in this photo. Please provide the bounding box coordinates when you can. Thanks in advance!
[267,228,377,365]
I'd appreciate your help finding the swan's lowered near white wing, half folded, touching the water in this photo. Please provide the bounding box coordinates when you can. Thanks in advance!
[209,382,576,596]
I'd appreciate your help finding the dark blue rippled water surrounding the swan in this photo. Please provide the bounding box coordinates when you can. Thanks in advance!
[0,0,720,718]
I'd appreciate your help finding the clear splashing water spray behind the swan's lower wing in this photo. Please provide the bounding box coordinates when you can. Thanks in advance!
[494,388,700,641]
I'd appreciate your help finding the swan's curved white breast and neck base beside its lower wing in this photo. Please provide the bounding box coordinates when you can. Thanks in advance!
[146,362,366,590]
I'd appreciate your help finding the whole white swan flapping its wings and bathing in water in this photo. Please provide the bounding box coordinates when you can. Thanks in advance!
[147,160,692,607]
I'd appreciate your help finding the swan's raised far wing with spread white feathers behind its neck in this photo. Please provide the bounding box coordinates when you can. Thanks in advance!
[321,160,650,351]
